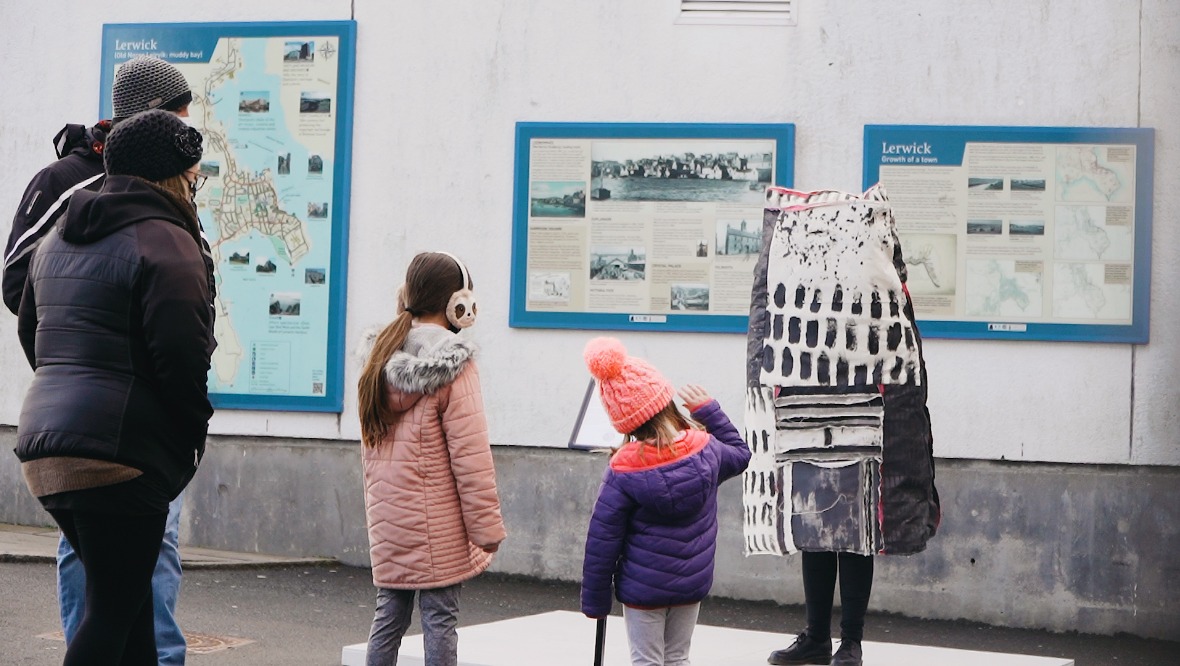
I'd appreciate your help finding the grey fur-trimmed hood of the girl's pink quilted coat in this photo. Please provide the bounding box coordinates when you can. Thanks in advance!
[375,324,477,412]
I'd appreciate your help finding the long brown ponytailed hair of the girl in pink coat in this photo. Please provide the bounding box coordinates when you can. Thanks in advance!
[356,252,474,446]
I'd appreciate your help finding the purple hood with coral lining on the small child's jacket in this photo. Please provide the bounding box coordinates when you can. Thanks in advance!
[610,430,717,518]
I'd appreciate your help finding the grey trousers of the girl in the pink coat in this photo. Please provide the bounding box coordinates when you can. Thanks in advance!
[365,585,463,666]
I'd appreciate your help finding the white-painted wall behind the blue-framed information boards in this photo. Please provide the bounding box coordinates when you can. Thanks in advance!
[0,0,1180,465]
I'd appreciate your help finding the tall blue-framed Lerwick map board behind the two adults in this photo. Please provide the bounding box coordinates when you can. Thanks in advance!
[100,21,356,412]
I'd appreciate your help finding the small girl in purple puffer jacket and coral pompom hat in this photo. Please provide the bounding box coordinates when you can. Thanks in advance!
[582,338,749,666]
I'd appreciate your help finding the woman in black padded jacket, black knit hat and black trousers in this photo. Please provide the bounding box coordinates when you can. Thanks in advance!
[17,110,214,666]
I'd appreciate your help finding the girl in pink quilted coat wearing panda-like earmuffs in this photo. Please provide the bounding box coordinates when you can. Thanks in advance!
[358,253,506,666]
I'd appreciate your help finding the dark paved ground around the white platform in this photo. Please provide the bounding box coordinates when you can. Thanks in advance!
[0,525,1180,666]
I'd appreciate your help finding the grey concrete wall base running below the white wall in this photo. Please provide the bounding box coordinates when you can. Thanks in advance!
[0,427,1180,640]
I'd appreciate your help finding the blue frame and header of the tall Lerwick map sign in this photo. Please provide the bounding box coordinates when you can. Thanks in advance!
[99,20,356,413]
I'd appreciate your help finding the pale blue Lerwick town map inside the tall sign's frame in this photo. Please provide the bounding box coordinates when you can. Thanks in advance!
[178,37,339,396]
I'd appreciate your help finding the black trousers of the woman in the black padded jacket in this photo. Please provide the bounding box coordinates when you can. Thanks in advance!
[50,509,168,666]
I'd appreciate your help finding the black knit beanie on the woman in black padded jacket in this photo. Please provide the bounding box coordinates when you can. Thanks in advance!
[103,109,203,183]
